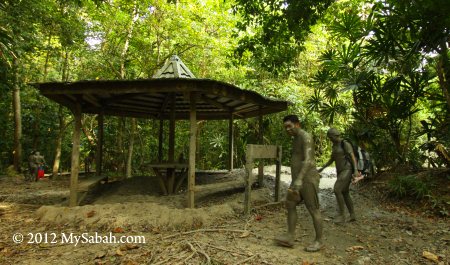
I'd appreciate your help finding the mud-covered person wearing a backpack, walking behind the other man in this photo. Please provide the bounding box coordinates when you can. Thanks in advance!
[319,128,359,223]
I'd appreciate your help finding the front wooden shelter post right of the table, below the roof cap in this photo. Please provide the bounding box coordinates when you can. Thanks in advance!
[187,92,197,208]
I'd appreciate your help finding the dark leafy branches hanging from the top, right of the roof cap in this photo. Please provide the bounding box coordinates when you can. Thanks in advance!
[234,0,333,75]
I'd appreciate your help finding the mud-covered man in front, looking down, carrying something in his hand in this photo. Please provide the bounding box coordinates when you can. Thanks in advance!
[275,115,323,252]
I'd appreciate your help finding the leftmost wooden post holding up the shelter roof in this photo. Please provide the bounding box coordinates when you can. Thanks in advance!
[69,103,81,207]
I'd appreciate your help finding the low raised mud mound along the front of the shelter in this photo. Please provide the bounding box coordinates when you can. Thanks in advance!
[36,202,237,231]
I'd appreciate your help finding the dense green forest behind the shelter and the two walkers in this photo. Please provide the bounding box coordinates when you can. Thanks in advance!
[0,0,450,184]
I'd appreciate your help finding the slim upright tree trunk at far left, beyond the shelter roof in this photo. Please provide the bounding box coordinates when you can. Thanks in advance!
[12,59,22,172]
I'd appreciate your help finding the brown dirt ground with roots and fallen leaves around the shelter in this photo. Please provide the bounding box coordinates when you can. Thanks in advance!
[0,167,450,265]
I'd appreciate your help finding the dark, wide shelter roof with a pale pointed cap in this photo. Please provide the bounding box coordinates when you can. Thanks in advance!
[34,57,288,120]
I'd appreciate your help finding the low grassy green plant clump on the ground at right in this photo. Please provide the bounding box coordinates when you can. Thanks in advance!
[388,175,431,200]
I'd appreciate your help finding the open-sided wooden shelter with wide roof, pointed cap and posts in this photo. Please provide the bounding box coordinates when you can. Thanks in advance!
[35,56,288,207]
